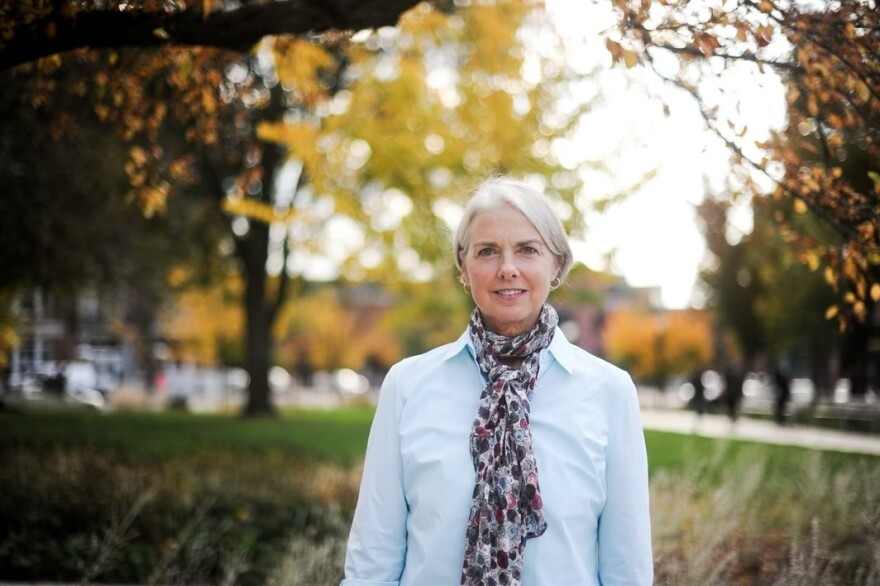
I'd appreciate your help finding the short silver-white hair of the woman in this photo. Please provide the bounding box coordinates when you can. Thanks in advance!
[453,176,574,284]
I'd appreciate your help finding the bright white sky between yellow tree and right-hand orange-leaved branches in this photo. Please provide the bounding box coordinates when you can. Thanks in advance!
[547,0,784,308]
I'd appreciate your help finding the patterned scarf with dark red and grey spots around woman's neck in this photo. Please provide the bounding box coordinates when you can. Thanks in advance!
[461,304,559,586]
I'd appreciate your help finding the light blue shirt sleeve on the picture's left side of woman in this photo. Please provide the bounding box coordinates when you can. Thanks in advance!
[340,364,407,586]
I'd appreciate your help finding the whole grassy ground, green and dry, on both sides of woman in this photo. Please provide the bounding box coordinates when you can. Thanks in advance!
[0,408,880,586]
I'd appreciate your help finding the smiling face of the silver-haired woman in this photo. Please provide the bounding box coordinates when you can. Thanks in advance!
[461,204,559,336]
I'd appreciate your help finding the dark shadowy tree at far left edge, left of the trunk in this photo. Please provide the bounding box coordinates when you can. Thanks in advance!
[0,76,229,381]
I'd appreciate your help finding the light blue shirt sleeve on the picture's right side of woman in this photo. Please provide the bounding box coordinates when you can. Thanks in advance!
[599,375,654,586]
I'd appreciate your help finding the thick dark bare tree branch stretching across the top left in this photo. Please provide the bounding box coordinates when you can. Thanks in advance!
[0,0,418,70]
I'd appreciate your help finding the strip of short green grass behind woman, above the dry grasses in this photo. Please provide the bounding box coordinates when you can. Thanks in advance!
[0,407,880,475]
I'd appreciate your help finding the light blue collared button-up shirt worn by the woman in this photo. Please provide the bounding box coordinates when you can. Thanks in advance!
[341,328,653,586]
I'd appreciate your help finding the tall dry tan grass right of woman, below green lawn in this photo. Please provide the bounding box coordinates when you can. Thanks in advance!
[651,442,880,586]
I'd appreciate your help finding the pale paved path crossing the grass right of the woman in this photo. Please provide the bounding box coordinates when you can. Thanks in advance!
[642,409,880,456]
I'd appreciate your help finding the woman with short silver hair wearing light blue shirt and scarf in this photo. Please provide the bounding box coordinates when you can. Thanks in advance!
[342,178,653,586]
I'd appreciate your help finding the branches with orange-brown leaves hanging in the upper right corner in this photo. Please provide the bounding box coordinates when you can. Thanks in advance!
[607,0,880,327]
